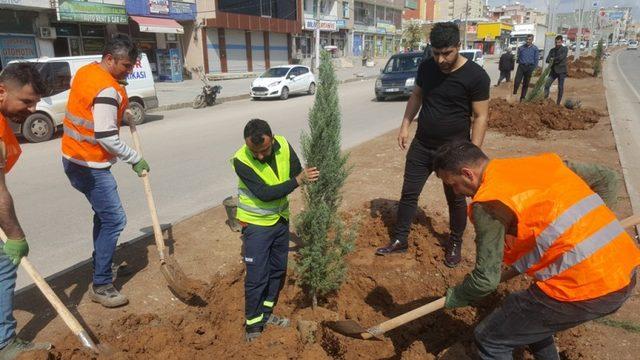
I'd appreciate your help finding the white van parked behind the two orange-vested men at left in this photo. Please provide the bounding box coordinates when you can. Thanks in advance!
[10,53,158,142]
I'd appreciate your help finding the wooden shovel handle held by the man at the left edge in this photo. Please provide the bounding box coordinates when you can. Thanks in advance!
[0,229,100,354]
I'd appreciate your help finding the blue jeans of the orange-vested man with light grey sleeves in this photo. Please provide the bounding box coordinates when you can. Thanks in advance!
[62,158,127,286]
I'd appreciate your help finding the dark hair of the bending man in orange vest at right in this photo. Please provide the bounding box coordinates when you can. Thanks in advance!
[433,141,489,173]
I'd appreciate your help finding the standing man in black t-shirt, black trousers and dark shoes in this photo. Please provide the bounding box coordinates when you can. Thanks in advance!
[376,22,491,267]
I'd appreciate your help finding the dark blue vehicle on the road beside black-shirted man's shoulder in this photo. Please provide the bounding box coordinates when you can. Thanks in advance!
[375,52,423,101]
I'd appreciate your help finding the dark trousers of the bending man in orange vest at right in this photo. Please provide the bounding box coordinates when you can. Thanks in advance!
[474,276,635,360]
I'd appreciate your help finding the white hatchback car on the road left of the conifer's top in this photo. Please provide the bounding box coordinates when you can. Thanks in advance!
[249,65,316,100]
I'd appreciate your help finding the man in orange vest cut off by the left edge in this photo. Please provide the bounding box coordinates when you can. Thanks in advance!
[0,63,51,359]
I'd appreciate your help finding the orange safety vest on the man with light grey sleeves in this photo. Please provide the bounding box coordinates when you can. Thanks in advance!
[62,63,129,168]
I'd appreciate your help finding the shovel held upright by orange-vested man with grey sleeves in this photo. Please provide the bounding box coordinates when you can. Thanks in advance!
[127,114,201,302]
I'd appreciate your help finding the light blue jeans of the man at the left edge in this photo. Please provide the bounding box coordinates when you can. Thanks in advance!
[0,247,18,348]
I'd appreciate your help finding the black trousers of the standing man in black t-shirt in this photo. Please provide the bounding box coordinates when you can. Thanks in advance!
[395,139,467,243]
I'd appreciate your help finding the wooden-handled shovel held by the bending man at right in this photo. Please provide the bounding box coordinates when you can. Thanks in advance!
[326,214,640,340]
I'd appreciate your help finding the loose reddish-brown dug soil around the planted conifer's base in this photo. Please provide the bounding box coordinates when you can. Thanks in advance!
[22,199,604,360]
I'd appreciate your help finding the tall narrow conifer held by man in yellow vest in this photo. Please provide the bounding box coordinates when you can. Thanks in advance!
[296,51,354,309]
